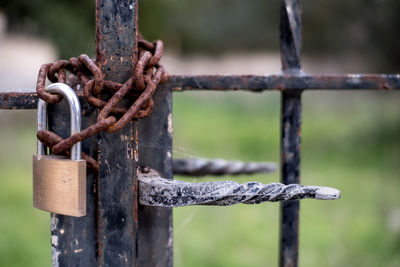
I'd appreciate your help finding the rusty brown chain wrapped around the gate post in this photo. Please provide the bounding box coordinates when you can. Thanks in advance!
[36,34,168,171]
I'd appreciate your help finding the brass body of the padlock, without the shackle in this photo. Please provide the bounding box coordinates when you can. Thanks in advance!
[33,155,86,217]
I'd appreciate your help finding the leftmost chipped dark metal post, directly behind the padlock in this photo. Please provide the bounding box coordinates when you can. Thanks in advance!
[48,101,98,267]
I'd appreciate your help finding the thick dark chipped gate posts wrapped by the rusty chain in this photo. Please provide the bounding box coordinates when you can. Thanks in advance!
[49,0,173,267]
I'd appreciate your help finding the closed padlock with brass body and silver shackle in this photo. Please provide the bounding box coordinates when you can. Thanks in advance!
[33,83,86,217]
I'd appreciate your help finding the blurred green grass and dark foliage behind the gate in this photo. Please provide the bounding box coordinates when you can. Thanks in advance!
[0,0,400,267]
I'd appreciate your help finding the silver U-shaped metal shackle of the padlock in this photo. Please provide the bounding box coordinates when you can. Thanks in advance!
[37,83,82,160]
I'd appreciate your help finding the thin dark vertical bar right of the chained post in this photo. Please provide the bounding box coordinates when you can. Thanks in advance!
[279,0,301,267]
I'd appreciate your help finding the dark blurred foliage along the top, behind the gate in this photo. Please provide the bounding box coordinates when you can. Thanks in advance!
[0,0,400,73]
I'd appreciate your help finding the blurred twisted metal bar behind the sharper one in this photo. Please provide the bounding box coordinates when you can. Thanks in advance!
[172,158,277,176]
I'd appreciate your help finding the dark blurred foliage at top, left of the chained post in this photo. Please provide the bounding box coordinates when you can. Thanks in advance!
[0,0,95,59]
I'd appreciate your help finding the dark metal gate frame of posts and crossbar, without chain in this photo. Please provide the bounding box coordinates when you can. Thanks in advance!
[0,0,400,266]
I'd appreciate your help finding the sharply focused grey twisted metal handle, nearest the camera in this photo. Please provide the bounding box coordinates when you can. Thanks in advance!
[139,171,340,207]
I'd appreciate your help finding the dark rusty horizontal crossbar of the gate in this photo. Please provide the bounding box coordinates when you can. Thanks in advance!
[0,74,400,109]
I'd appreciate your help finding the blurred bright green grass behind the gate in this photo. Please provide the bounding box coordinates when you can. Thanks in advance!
[0,92,400,267]
